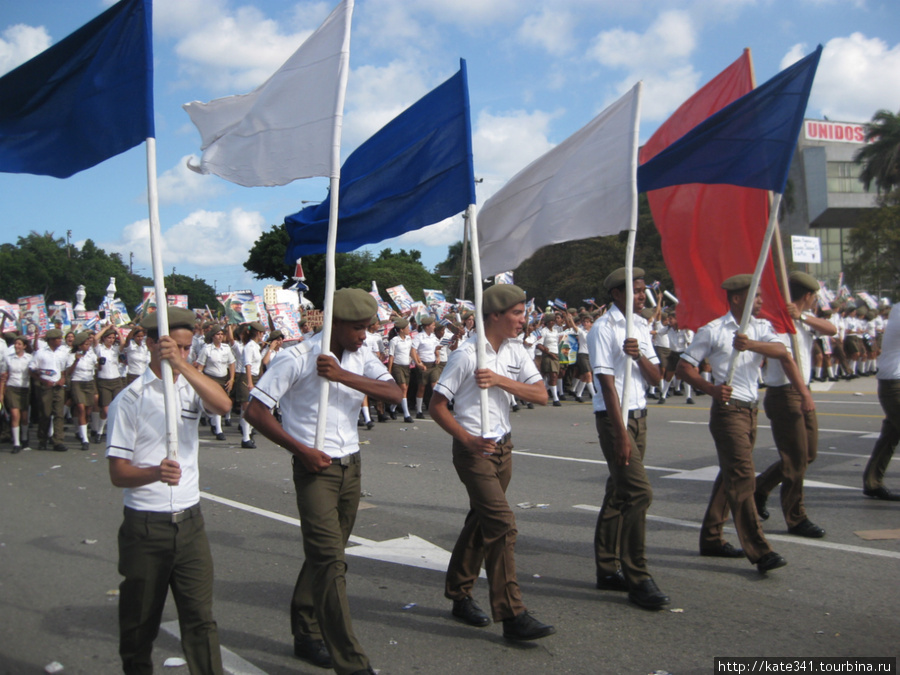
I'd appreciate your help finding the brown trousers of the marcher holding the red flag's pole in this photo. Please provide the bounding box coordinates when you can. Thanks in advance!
[756,384,819,527]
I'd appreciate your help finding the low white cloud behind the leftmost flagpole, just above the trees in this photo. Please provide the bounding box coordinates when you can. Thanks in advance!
[107,208,266,267]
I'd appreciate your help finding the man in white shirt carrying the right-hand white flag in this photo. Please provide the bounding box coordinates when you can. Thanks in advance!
[587,267,669,609]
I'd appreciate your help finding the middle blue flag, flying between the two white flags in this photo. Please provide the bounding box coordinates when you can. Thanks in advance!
[284,59,475,265]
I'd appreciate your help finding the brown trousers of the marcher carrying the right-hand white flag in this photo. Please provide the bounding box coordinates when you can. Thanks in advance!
[594,413,653,586]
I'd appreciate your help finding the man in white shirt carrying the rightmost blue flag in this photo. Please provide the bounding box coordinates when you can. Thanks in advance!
[676,274,804,573]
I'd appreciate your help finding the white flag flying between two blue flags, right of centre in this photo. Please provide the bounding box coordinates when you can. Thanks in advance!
[478,83,640,277]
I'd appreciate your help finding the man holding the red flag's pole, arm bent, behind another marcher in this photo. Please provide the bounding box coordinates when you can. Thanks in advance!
[754,272,837,539]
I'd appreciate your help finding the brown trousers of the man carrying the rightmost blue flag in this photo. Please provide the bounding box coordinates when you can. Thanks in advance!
[700,401,772,564]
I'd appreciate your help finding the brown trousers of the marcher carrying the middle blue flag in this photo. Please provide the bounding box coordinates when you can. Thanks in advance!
[444,435,525,621]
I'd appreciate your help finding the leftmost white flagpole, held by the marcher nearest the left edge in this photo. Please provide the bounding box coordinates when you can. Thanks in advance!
[147,137,178,460]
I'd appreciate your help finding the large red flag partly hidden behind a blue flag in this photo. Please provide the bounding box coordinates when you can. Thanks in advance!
[639,49,794,332]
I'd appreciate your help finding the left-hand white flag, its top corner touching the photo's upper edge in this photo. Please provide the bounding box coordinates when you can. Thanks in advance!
[182,0,353,187]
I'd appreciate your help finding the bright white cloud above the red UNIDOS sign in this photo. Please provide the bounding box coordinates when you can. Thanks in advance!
[781,33,900,122]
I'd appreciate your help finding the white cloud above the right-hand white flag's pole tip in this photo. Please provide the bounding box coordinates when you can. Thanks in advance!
[588,10,700,121]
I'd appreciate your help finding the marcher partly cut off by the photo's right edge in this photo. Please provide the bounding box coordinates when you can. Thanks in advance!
[863,304,900,502]
